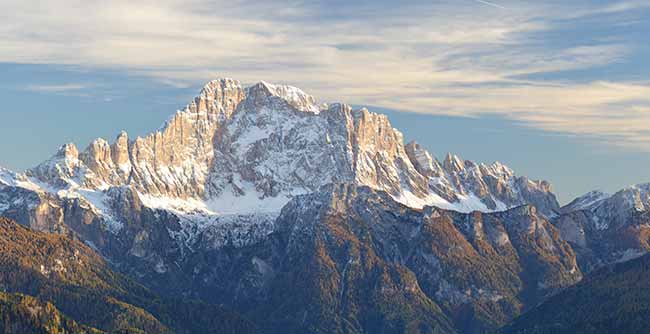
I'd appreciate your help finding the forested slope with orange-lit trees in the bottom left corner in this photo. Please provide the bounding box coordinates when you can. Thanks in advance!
[0,218,254,333]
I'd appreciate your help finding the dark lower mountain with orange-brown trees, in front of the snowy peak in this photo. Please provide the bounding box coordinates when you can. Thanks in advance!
[156,184,581,333]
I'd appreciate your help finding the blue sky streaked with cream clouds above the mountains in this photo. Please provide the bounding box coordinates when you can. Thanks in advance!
[0,0,650,202]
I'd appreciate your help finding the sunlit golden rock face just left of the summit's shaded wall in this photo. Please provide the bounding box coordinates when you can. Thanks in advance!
[114,79,244,198]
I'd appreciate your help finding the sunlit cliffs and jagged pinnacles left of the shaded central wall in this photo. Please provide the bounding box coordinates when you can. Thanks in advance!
[26,79,244,198]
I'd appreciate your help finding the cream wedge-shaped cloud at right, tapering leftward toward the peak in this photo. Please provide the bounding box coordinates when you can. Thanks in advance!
[372,82,650,150]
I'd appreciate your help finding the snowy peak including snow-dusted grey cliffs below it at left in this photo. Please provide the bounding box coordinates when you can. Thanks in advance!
[0,79,559,268]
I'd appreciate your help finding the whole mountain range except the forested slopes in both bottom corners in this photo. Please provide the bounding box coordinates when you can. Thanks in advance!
[0,79,650,333]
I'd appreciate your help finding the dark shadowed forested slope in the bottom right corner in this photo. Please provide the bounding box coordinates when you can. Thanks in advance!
[500,255,650,334]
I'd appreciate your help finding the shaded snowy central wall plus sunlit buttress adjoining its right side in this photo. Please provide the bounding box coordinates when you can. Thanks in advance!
[210,96,427,206]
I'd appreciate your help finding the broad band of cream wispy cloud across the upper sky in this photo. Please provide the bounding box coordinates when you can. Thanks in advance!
[0,0,650,150]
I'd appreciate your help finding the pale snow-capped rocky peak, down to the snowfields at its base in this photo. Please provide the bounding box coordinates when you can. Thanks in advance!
[3,79,558,245]
